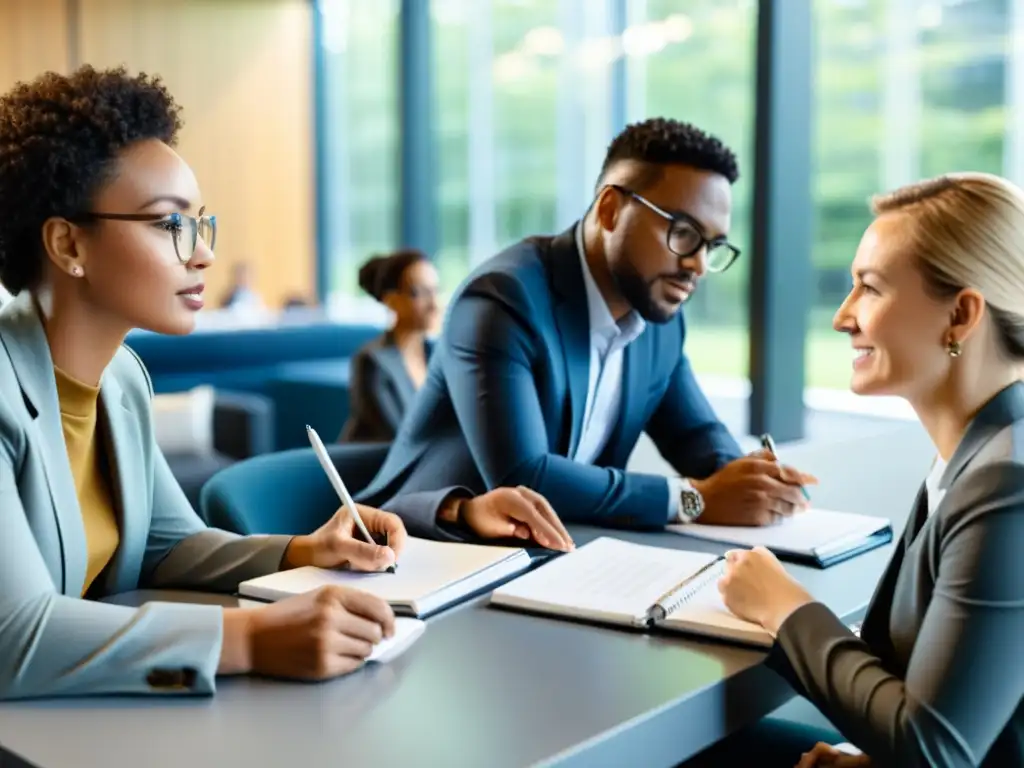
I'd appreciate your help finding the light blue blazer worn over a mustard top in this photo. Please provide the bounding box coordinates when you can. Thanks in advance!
[0,292,289,698]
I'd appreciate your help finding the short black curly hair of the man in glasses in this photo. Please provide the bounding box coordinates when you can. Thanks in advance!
[598,118,739,186]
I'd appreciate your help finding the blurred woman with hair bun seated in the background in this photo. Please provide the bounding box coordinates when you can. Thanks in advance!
[339,249,437,442]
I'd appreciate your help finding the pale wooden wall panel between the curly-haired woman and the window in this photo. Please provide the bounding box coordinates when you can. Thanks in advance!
[76,0,315,306]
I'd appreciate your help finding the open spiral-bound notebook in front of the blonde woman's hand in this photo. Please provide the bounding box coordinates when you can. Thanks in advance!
[490,537,774,647]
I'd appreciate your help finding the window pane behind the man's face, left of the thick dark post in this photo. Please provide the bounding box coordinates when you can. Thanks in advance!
[624,0,757,379]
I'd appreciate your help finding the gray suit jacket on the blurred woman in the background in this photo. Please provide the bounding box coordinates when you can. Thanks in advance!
[338,333,433,442]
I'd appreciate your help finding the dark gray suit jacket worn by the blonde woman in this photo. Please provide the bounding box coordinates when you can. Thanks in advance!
[769,383,1024,768]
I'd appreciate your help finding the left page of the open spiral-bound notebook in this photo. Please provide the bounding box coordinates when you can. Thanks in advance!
[492,537,715,623]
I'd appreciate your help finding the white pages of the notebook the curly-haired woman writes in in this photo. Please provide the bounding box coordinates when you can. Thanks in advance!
[239,538,528,604]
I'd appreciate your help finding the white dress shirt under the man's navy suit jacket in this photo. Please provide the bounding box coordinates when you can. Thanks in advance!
[572,222,683,522]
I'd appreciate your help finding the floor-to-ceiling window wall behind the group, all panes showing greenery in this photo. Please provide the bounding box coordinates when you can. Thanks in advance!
[319,0,1024,415]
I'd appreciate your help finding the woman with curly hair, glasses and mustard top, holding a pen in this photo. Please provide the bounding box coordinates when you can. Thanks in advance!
[0,67,565,699]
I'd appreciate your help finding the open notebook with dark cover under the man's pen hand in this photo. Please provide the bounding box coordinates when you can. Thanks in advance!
[668,509,893,568]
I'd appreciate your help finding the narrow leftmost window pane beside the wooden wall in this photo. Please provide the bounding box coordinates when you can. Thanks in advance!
[319,0,399,317]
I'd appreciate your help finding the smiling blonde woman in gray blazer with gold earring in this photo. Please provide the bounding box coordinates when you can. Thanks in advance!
[706,173,1024,768]
